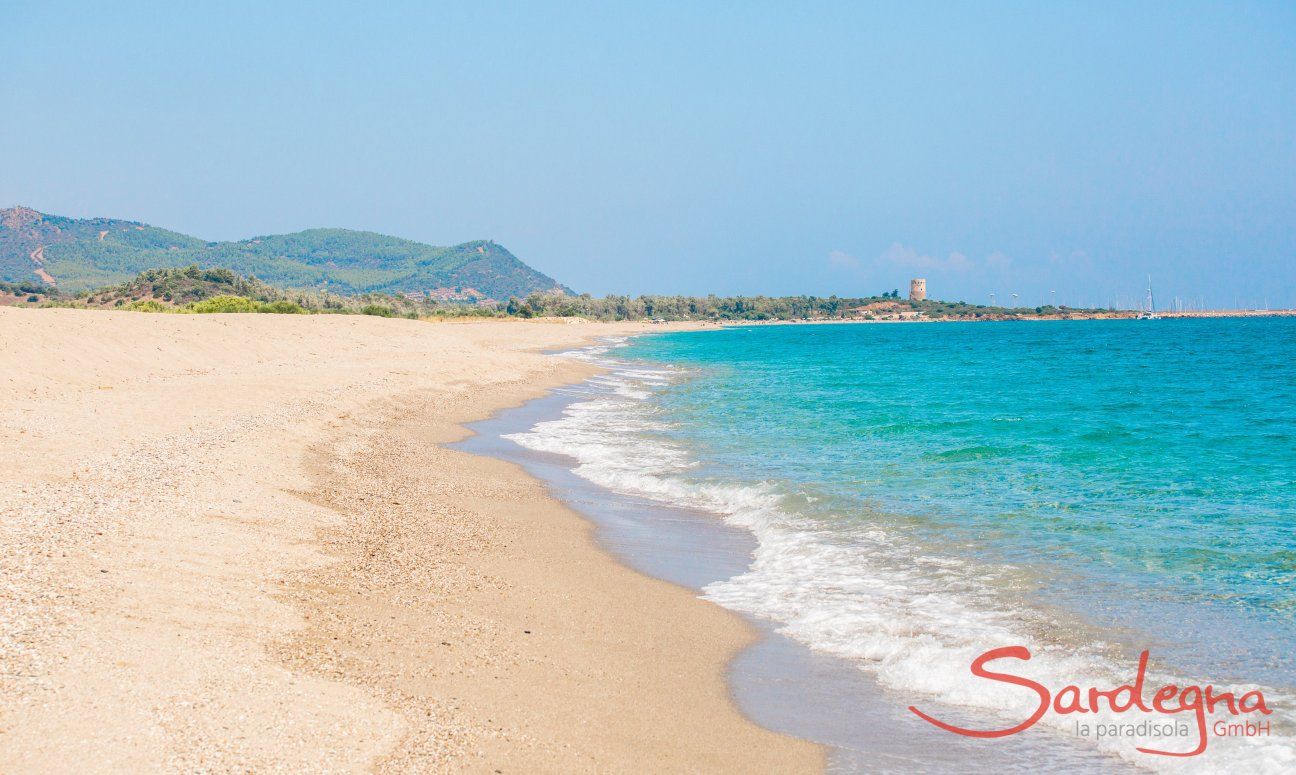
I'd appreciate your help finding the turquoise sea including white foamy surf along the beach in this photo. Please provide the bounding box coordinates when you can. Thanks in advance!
[512,319,1296,771]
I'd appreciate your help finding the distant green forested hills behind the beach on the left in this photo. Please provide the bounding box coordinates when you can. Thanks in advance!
[0,207,568,301]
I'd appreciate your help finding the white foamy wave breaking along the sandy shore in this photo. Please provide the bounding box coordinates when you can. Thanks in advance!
[507,340,1296,772]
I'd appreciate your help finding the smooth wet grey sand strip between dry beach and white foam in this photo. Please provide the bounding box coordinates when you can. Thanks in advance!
[476,342,1133,772]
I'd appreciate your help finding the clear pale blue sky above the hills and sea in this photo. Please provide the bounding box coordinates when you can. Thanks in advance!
[0,0,1296,306]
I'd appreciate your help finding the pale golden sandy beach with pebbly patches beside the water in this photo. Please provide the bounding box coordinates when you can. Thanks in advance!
[0,308,824,772]
